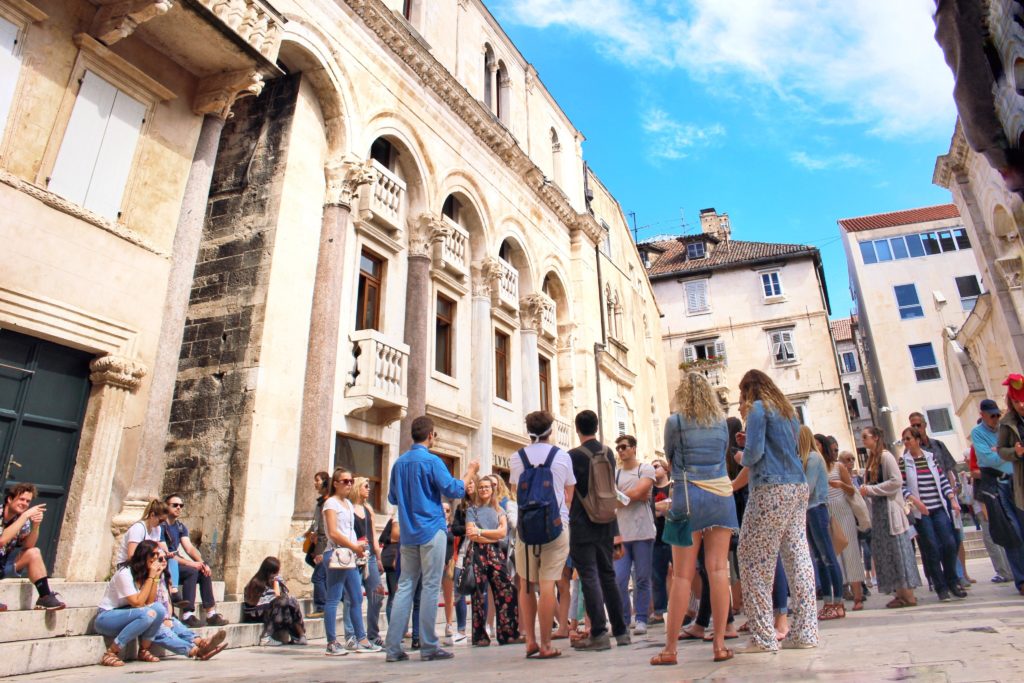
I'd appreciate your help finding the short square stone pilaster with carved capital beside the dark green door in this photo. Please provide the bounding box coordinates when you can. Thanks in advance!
[53,355,145,581]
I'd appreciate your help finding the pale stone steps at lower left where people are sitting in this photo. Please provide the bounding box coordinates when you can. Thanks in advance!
[0,579,344,678]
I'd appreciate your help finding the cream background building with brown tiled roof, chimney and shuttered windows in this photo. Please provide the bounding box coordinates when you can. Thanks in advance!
[640,209,853,449]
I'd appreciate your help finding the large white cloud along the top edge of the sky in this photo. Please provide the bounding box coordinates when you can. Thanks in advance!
[503,0,955,137]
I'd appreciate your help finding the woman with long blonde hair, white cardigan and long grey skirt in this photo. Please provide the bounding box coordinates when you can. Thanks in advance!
[860,427,921,607]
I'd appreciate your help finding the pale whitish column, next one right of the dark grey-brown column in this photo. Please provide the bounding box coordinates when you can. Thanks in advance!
[468,264,498,474]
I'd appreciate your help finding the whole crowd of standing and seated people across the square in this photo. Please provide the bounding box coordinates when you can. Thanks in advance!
[6,370,1024,667]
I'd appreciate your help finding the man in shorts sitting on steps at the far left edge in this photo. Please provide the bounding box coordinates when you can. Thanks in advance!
[0,483,65,611]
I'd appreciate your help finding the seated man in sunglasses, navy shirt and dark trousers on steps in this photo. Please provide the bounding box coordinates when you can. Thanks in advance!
[160,494,227,629]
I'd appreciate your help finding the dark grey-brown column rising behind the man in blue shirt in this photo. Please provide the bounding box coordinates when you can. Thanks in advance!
[398,213,452,452]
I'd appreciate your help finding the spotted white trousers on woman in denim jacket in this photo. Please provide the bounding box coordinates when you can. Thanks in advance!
[738,483,818,650]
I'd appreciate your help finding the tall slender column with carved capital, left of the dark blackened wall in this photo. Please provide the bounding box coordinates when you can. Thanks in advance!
[121,71,263,520]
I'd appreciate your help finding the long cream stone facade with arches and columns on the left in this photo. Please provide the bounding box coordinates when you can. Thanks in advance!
[0,0,668,592]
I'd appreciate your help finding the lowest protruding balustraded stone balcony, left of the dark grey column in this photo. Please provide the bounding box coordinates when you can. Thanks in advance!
[345,330,409,426]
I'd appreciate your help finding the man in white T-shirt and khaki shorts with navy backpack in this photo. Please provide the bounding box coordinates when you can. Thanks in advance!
[509,411,575,659]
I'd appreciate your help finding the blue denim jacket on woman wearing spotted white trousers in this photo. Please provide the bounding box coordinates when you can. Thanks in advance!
[742,400,807,488]
